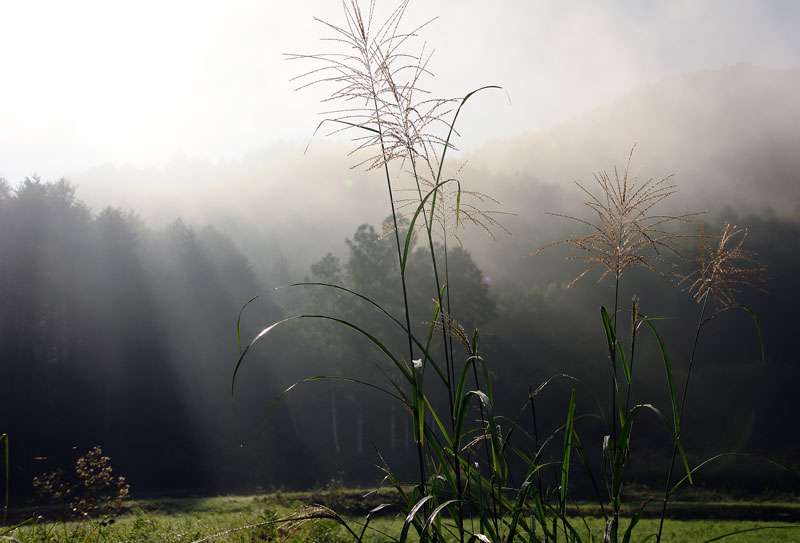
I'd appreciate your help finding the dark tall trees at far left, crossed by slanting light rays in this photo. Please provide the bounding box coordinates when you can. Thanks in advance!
[0,178,282,493]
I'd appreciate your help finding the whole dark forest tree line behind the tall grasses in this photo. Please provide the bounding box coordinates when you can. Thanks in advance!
[0,178,800,495]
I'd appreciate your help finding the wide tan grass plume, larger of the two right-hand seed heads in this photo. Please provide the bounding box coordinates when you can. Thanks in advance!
[531,144,697,286]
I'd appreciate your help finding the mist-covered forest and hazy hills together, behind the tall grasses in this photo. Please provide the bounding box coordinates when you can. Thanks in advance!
[0,66,800,502]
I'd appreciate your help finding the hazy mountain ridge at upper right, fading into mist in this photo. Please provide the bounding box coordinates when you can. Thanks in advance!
[470,64,800,213]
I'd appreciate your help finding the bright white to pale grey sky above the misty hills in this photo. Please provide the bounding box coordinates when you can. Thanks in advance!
[0,0,800,185]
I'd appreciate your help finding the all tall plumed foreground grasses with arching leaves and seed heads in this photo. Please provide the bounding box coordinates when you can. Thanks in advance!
[231,0,800,543]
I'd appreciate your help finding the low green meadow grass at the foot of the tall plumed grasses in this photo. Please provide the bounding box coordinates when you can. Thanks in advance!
[8,498,800,543]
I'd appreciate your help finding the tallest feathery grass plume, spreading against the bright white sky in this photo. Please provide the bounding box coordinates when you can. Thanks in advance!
[287,0,455,170]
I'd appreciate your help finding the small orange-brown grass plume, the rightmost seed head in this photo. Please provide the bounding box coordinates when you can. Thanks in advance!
[681,222,769,307]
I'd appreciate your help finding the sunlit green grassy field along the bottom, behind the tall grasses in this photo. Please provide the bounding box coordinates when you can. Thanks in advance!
[6,490,800,543]
